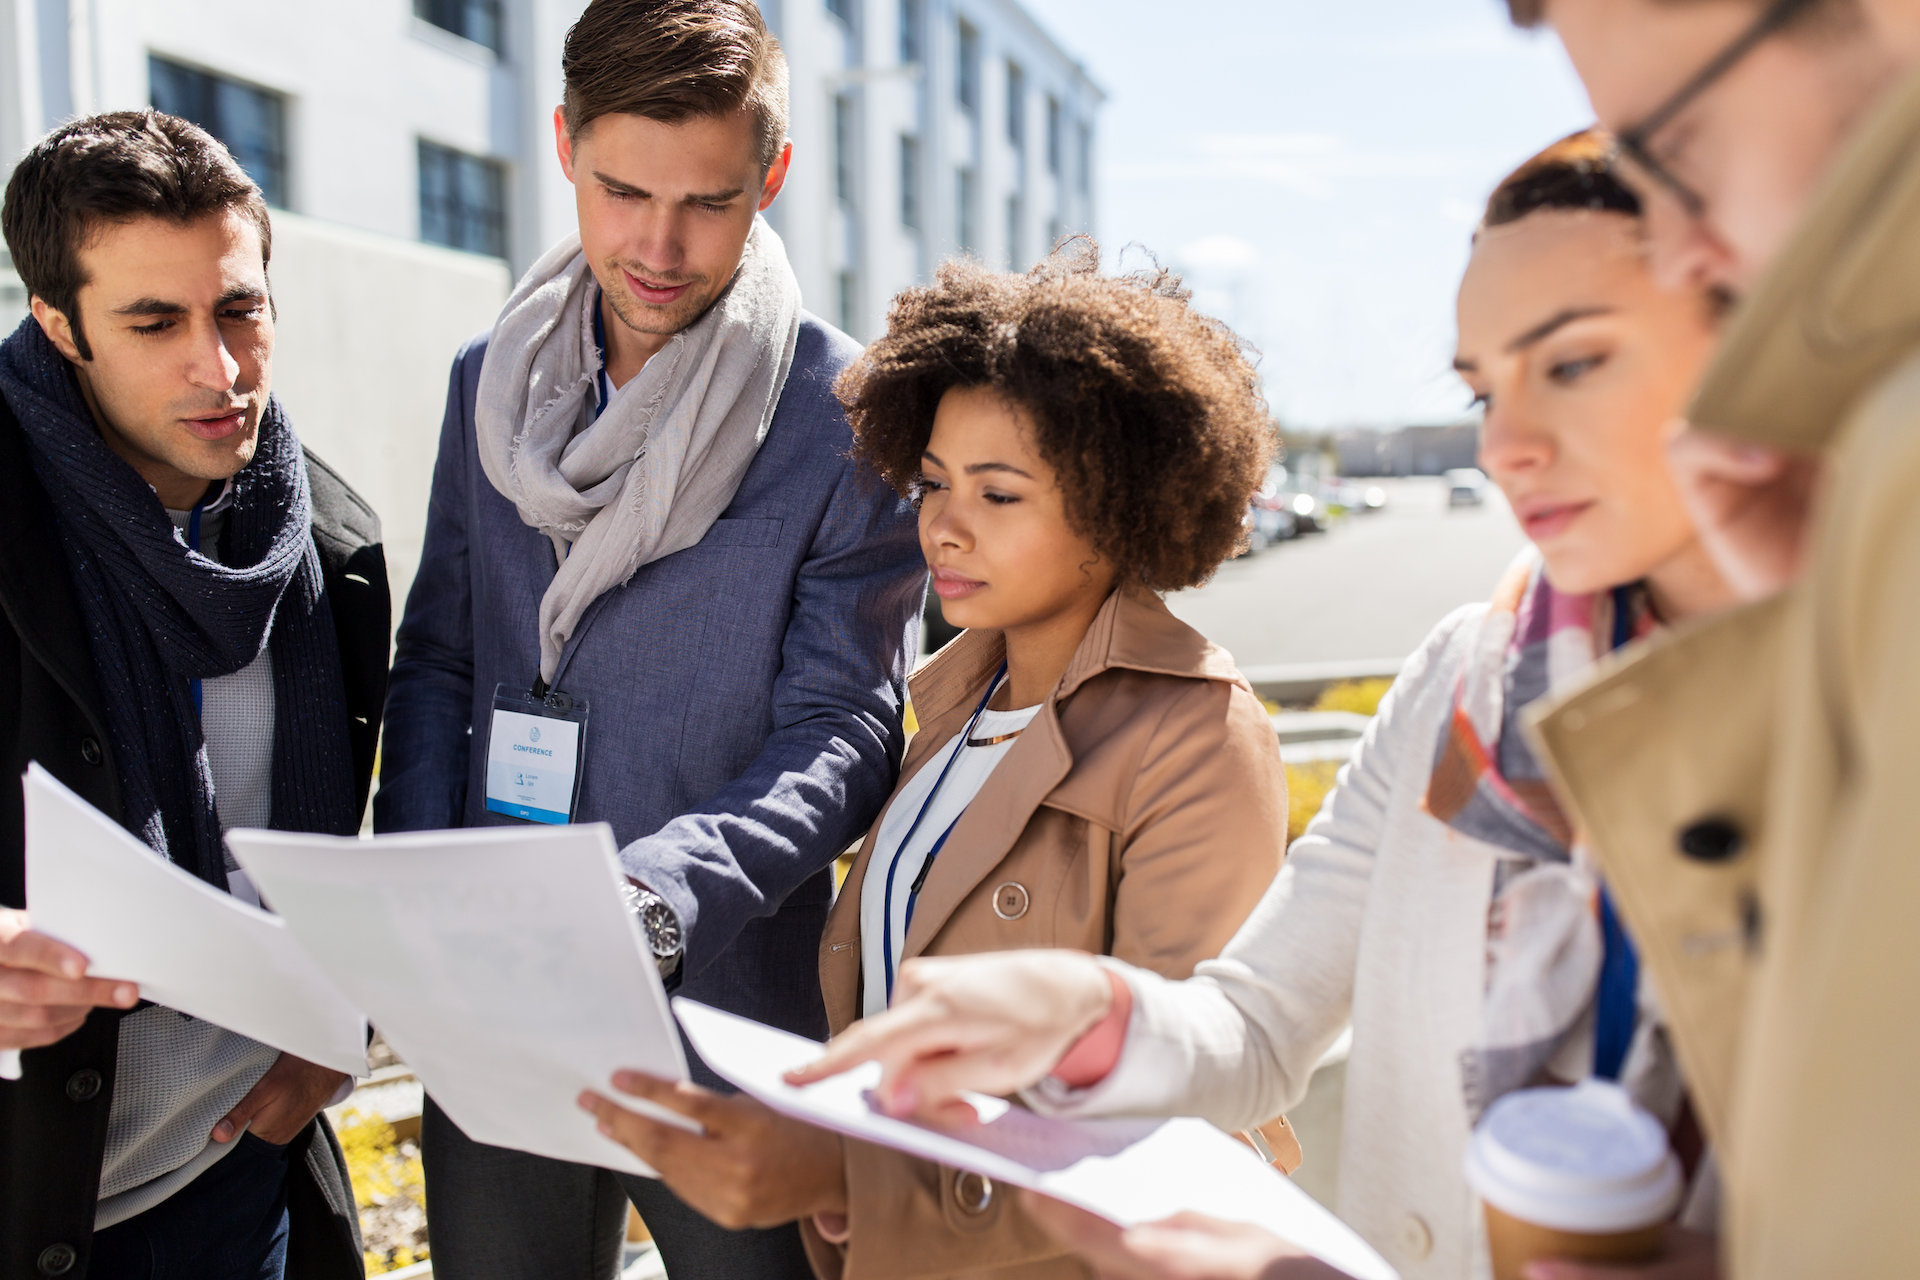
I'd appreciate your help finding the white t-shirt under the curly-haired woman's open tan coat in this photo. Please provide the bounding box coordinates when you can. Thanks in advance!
[860,694,1041,1017]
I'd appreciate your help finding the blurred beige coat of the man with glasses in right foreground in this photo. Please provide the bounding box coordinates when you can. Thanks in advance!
[1536,65,1920,1280]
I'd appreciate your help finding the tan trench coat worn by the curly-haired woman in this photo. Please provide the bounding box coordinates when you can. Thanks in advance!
[803,591,1286,1280]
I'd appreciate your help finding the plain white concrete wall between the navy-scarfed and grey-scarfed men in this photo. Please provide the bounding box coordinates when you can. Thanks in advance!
[271,213,509,622]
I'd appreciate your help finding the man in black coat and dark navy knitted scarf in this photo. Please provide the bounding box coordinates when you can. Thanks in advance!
[0,111,390,1280]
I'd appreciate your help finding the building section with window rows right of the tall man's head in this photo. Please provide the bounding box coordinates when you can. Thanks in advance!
[762,0,1104,342]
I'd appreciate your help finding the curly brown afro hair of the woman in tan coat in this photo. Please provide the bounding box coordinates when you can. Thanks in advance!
[833,238,1275,591]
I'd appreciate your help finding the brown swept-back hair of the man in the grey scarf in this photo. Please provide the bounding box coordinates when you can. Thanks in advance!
[561,0,787,169]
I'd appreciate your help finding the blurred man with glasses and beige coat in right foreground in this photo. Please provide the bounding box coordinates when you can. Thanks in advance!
[1482,0,1920,1280]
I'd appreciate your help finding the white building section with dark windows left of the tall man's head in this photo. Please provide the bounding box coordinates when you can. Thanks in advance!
[0,0,584,280]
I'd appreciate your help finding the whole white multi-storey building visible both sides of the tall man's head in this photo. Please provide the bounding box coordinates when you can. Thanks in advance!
[0,0,1102,338]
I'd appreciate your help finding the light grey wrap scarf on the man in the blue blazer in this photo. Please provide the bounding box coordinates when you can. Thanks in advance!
[487,217,801,683]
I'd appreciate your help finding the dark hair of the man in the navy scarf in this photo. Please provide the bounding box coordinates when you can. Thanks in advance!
[0,111,273,361]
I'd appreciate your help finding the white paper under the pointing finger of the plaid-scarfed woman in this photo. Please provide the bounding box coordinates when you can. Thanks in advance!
[674,1000,1398,1280]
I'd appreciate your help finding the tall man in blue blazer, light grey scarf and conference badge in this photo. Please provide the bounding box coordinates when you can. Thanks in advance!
[374,0,925,1280]
